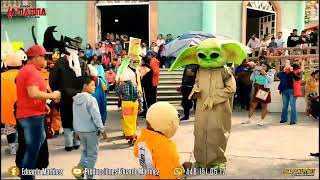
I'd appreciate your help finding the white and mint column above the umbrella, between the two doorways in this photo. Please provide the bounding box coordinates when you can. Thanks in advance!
[202,1,217,33]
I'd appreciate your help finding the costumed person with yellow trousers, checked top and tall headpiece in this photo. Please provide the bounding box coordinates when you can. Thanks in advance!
[116,38,142,146]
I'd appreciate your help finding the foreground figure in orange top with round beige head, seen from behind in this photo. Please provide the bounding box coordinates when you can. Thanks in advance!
[134,102,185,179]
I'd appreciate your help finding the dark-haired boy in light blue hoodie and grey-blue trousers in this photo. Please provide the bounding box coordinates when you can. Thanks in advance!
[73,77,104,179]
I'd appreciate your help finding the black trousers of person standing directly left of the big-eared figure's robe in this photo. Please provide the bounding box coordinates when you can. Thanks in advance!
[181,86,197,117]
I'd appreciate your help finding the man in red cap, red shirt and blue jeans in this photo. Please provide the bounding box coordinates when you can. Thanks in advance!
[16,45,61,179]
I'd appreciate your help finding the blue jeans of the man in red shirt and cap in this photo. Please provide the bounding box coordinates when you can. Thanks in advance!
[18,115,46,169]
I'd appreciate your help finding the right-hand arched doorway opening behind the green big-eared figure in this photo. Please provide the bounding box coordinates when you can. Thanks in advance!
[246,8,276,42]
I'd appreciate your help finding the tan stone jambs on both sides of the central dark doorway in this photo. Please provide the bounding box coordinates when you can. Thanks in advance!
[87,1,158,46]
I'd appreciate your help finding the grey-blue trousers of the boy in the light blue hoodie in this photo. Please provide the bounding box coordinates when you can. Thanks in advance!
[79,132,99,179]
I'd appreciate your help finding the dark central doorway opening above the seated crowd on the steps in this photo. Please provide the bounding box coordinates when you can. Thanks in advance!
[98,5,149,44]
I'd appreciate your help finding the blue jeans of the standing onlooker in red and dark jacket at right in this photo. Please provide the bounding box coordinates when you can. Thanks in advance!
[281,89,297,122]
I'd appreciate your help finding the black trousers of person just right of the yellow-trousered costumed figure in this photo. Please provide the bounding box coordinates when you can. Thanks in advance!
[142,86,157,114]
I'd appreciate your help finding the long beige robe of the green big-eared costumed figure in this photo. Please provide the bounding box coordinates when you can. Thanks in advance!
[189,67,236,167]
